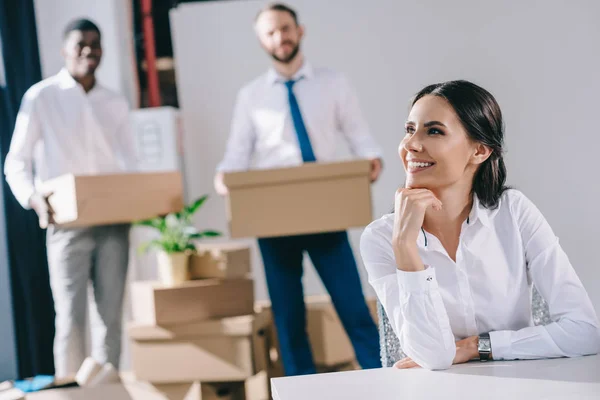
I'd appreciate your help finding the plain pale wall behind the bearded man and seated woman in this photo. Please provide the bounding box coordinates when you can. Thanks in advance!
[171,0,600,311]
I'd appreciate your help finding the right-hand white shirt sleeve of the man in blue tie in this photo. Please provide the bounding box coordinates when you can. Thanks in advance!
[337,76,382,159]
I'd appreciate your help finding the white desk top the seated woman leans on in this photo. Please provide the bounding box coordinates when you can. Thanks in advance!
[271,355,600,400]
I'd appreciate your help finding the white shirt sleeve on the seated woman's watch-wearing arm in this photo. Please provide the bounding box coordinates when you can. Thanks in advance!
[490,193,600,360]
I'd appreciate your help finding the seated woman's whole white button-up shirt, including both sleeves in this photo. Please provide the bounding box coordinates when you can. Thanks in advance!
[361,190,600,369]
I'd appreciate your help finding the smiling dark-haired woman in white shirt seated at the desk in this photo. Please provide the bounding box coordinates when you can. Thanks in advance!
[361,81,600,369]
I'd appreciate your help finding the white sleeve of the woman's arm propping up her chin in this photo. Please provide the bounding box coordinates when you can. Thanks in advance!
[360,220,456,370]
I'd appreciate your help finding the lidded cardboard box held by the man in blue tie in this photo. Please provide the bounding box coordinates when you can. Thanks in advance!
[224,160,373,238]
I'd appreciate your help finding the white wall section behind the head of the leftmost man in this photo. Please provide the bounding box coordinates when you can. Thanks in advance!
[34,0,138,108]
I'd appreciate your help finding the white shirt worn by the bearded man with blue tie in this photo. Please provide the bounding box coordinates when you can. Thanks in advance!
[217,62,381,172]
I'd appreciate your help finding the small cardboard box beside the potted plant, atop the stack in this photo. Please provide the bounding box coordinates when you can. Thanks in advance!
[190,243,251,279]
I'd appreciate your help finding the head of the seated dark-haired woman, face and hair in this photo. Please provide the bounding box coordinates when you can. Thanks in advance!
[399,81,506,208]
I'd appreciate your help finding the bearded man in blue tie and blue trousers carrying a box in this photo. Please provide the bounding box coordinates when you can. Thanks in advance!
[215,4,382,375]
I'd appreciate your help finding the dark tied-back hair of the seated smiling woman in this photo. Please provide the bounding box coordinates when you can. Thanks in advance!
[412,80,508,209]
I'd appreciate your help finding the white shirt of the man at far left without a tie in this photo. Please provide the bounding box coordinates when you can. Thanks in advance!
[4,69,137,208]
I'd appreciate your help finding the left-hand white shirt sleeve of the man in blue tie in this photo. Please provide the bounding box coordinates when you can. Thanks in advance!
[217,89,256,172]
